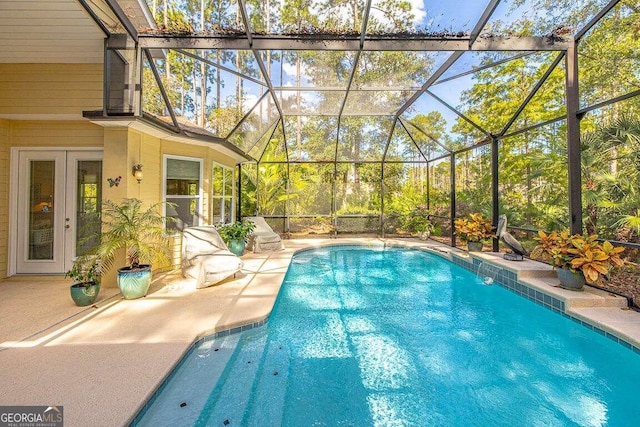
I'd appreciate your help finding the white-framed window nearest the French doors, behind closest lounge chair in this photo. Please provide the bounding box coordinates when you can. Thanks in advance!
[164,156,202,230]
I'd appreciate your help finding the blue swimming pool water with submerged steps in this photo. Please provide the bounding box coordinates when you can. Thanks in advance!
[138,246,640,427]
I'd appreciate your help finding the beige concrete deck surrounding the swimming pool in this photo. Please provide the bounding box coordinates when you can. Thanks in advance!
[0,238,640,427]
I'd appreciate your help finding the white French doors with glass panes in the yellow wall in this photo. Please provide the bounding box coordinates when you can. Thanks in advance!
[15,150,102,274]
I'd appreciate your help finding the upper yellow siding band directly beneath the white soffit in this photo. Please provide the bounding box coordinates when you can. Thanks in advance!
[0,64,102,114]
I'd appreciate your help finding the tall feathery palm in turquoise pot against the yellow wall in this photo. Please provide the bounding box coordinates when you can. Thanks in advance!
[94,199,172,299]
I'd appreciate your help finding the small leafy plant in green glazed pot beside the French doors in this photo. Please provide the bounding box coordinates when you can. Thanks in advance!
[65,255,102,307]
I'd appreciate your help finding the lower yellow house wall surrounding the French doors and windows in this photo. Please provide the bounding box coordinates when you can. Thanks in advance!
[0,119,240,286]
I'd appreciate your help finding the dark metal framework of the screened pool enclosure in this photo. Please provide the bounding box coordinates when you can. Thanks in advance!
[78,0,640,249]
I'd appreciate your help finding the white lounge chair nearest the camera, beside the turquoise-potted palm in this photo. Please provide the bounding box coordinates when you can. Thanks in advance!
[182,225,242,288]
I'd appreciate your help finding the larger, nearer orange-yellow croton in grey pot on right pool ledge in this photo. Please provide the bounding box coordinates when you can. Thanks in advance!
[531,231,626,290]
